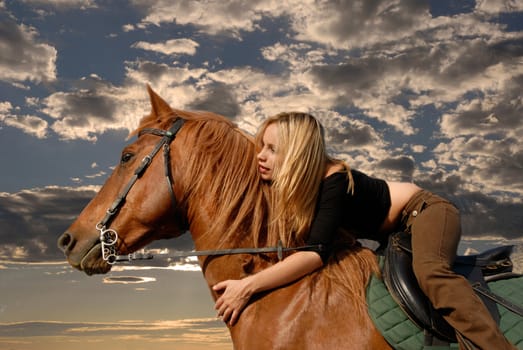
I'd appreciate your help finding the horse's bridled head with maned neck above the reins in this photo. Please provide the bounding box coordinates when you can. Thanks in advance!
[58,88,268,274]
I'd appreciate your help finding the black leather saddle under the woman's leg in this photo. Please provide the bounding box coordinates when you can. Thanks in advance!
[383,232,521,345]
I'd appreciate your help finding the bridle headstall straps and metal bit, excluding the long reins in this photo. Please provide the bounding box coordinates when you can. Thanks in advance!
[96,117,185,264]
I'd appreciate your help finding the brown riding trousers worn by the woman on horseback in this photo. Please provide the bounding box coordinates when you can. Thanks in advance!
[402,191,516,350]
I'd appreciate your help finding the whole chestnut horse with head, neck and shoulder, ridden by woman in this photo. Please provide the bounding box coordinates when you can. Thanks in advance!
[58,88,391,350]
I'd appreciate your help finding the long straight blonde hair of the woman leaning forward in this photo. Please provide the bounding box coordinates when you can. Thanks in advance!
[256,112,352,246]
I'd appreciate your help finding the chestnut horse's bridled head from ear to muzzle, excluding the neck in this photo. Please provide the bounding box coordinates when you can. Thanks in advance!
[58,88,192,274]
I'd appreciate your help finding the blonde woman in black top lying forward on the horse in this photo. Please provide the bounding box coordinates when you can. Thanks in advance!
[213,113,515,349]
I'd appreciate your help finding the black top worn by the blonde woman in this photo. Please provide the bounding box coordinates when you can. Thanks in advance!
[306,169,391,261]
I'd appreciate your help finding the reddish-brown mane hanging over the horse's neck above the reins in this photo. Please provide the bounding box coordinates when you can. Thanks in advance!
[170,110,268,249]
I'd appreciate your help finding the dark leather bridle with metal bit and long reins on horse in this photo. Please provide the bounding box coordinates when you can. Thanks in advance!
[96,116,325,265]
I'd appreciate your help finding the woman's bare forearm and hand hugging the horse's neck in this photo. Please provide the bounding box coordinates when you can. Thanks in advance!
[212,251,323,326]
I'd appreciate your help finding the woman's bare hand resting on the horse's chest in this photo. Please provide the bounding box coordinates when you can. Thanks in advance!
[212,278,252,326]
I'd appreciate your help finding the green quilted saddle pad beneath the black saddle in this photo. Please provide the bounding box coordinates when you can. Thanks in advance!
[367,257,523,350]
